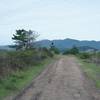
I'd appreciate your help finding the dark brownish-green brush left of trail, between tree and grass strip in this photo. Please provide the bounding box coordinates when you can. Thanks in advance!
[0,48,53,79]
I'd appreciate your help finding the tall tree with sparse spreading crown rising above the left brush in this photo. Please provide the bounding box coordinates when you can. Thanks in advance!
[12,29,38,50]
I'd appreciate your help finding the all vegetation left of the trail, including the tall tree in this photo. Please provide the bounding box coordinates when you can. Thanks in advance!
[0,29,57,100]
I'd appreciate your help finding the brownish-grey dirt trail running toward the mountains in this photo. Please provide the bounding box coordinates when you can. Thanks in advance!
[13,57,99,100]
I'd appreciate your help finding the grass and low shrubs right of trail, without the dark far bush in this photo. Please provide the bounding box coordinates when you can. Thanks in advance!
[79,52,100,89]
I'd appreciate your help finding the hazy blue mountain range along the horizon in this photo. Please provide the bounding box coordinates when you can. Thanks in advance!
[0,38,100,51]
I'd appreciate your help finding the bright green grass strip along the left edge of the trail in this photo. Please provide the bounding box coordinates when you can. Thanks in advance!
[0,59,53,100]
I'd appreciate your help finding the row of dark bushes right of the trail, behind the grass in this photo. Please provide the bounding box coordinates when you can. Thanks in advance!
[63,46,100,65]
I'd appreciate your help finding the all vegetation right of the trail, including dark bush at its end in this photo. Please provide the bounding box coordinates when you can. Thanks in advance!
[63,47,100,89]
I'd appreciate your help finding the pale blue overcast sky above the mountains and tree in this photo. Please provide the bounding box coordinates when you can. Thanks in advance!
[0,0,100,45]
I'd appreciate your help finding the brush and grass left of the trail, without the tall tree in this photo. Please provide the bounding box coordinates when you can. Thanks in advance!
[0,48,54,100]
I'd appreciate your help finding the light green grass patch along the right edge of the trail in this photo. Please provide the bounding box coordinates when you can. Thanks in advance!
[80,59,100,89]
